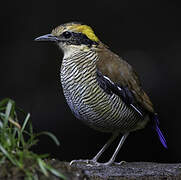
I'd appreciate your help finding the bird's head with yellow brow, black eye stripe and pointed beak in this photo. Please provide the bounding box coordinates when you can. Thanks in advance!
[35,22,100,54]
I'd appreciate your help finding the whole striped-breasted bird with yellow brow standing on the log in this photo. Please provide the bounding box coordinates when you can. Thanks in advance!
[35,22,167,166]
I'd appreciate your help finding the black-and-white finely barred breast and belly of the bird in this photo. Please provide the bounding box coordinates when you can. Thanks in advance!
[61,51,146,132]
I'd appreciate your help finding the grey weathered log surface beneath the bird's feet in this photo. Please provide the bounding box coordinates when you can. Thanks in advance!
[66,162,181,180]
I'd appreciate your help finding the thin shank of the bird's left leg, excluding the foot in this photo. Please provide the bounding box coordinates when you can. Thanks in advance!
[92,132,119,163]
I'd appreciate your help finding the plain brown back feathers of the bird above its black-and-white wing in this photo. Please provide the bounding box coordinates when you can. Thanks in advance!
[97,44,154,113]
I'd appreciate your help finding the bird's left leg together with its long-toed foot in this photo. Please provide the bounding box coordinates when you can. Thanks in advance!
[70,132,119,165]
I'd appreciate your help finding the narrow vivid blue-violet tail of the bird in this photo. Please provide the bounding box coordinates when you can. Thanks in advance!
[153,114,168,149]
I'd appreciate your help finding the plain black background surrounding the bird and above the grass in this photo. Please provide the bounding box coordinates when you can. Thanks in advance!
[0,0,181,162]
